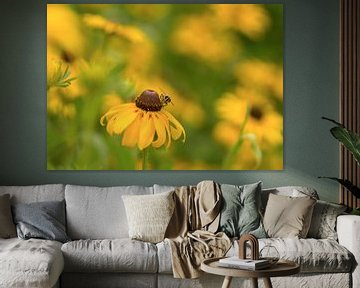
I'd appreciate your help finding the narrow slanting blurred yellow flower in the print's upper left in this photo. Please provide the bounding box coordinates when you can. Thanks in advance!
[83,14,146,43]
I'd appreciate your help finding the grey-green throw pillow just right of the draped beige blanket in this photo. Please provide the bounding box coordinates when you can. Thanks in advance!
[219,182,266,238]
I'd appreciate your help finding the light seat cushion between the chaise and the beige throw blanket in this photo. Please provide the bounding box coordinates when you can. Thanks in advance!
[61,239,158,273]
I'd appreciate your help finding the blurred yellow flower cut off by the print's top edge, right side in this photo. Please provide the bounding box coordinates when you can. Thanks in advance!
[210,4,270,39]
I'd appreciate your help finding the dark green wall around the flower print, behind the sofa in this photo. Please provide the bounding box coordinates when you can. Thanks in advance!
[0,0,339,201]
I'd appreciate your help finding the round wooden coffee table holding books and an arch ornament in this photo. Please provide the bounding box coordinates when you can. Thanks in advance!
[201,258,300,288]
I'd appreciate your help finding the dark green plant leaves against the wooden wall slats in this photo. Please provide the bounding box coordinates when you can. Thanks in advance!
[319,117,360,215]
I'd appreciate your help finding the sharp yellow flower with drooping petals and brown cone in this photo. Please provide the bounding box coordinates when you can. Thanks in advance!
[100,90,185,150]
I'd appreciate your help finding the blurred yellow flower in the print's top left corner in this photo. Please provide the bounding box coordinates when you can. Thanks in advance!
[47,4,85,60]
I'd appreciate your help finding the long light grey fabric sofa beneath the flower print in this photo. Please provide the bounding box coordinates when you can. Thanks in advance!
[0,184,360,288]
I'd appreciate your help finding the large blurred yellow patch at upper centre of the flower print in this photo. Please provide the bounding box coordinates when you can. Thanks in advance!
[171,14,239,64]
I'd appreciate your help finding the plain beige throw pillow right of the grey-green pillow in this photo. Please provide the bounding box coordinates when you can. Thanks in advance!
[264,194,316,238]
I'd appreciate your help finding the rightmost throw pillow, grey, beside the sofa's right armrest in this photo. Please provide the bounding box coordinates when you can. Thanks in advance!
[308,200,346,240]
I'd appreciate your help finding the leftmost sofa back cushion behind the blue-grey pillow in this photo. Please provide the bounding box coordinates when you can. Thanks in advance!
[0,184,65,204]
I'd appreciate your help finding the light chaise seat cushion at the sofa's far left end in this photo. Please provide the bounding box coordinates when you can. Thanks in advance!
[0,238,64,288]
